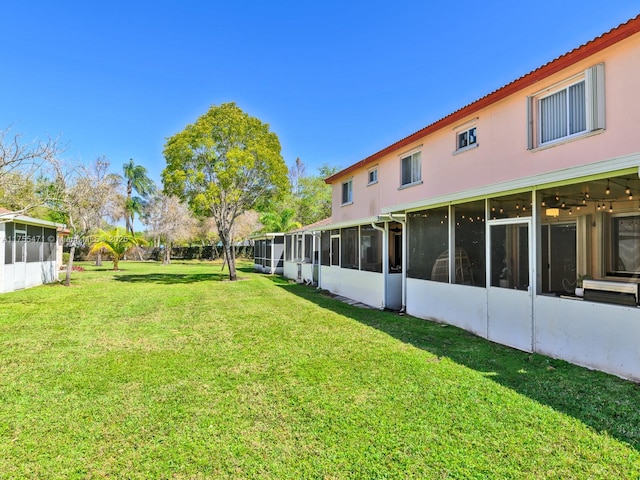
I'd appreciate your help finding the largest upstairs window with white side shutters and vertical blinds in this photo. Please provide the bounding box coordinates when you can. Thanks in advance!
[527,64,605,150]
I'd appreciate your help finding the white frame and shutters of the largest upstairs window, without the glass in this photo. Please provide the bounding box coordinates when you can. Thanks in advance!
[527,63,605,151]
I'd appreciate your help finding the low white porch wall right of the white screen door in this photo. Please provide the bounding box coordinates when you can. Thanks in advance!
[534,296,640,381]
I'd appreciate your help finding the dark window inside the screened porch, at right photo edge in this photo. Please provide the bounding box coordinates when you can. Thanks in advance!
[611,215,640,275]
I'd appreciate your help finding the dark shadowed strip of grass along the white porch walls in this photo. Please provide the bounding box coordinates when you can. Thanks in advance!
[274,278,640,451]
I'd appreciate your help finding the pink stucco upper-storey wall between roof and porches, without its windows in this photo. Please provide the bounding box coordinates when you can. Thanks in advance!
[332,35,640,223]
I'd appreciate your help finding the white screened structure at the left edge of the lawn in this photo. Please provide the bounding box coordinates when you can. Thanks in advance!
[0,211,63,293]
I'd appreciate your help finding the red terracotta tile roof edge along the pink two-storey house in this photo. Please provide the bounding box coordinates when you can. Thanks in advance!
[325,15,640,184]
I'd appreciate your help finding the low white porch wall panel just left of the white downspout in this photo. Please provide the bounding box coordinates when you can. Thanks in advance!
[320,265,384,308]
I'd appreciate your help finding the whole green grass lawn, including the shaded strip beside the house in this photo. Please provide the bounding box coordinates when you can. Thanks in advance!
[0,262,640,479]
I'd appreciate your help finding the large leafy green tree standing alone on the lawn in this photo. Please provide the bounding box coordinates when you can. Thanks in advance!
[162,103,289,280]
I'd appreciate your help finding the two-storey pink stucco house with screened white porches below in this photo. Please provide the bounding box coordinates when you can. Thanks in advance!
[283,16,640,380]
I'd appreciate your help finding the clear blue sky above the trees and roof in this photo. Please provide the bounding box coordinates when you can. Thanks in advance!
[0,0,640,186]
